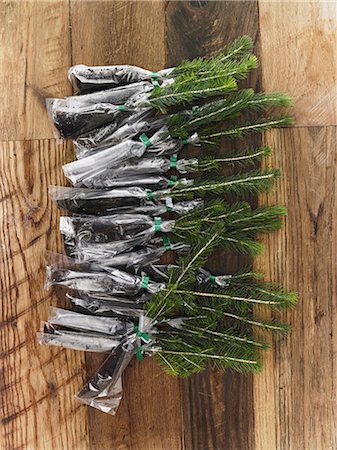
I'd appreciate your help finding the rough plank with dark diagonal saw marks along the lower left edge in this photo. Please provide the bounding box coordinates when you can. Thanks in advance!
[0,140,88,450]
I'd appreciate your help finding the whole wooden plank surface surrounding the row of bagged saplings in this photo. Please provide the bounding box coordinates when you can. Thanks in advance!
[0,0,337,450]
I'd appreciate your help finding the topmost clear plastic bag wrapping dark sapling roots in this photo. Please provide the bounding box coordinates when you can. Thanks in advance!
[68,64,173,93]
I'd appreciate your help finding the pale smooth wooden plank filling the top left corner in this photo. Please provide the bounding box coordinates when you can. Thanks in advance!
[0,0,71,140]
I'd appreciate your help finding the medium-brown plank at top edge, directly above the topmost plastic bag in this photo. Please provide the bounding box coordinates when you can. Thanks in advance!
[71,0,165,70]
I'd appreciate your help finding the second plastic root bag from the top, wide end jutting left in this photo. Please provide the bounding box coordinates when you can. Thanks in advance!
[46,82,153,139]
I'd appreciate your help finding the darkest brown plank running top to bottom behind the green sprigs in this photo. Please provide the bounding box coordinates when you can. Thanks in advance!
[167,1,260,450]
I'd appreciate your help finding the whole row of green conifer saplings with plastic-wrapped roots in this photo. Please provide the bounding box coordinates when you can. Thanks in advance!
[38,36,296,414]
